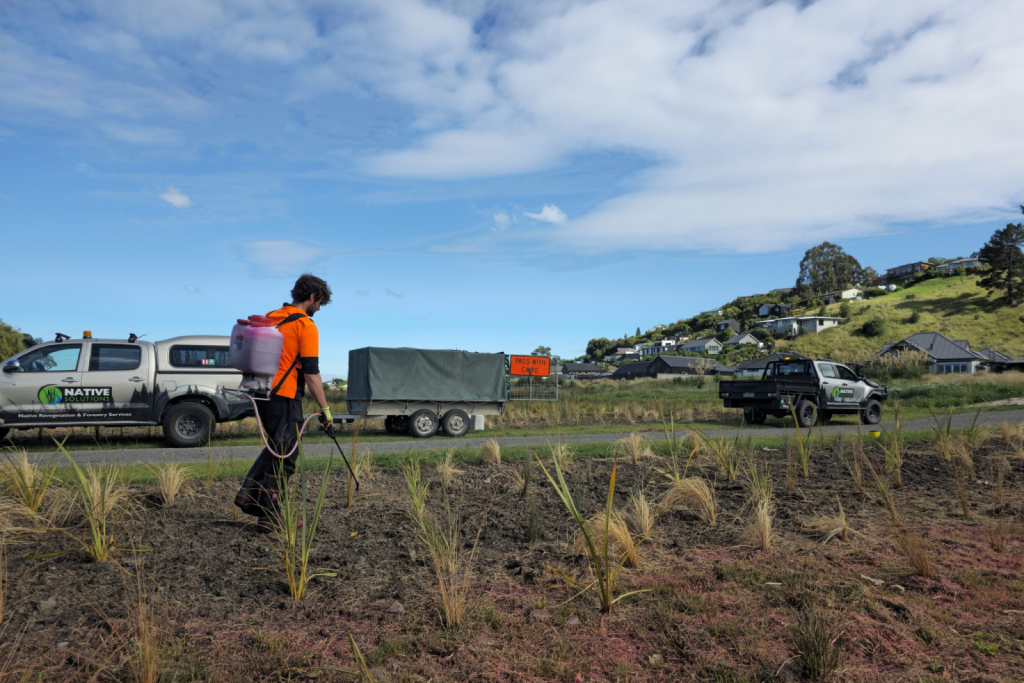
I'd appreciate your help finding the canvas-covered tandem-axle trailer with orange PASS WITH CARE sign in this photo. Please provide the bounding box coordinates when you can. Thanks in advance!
[336,346,558,438]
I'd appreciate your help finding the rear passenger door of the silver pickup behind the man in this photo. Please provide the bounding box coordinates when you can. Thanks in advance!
[82,342,153,422]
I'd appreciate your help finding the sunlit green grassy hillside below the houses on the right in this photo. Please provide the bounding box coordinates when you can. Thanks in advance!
[778,275,1024,359]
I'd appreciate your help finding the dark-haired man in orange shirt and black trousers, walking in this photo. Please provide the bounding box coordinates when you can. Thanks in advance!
[234,273,333,530]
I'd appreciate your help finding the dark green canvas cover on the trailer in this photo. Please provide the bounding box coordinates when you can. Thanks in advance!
[346,346,511,402]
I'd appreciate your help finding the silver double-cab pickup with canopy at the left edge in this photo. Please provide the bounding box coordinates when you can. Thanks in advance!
[0,334,253,446]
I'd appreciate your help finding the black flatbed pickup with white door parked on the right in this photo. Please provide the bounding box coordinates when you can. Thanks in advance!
[719,358,889,427]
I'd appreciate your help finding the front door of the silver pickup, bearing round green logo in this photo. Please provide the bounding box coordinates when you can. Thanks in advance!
[0,343,82,424]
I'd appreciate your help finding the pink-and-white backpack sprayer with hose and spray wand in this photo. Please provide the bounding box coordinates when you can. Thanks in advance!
[221,313,359,490]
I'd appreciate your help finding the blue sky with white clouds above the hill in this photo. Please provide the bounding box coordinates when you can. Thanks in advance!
[0,0,1024,377]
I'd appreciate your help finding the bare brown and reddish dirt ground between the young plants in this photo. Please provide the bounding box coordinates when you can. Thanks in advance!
[0,438,1024,683]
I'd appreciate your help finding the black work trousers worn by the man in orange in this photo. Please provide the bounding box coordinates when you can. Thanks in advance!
[239,396,302,512]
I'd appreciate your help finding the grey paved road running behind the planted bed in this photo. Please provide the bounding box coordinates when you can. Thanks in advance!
[29,410,1024,465]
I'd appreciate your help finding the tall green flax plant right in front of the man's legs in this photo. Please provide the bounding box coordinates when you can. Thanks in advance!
[271,439,337,601]
